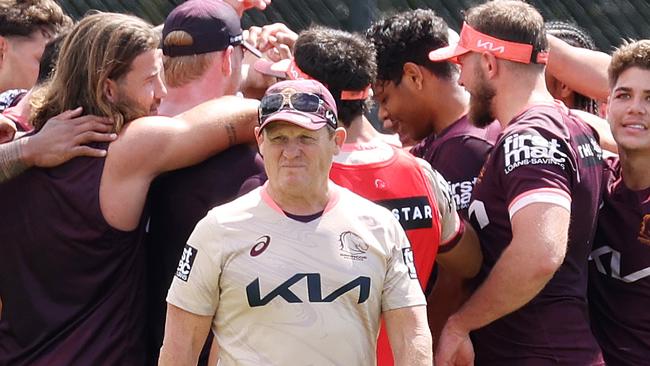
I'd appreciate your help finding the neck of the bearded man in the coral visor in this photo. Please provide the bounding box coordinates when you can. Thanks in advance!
[493,71,553,128]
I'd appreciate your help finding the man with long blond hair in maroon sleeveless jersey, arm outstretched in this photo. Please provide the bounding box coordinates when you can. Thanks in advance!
[0,13,258,365]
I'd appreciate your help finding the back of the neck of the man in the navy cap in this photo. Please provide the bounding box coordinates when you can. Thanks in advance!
[158,78,227,117]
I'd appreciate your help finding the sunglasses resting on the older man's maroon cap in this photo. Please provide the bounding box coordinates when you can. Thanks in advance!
[258,92,337,129]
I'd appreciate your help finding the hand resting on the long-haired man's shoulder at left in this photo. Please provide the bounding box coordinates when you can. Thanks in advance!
[20,107,117,167]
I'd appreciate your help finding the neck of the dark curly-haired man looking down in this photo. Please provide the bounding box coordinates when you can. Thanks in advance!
[428,78,469,134]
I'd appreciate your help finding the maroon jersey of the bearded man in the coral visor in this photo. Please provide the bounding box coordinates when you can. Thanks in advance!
[468,103,602,366]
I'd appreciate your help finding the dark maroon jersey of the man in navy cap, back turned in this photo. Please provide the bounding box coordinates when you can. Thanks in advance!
[146,145,264,365]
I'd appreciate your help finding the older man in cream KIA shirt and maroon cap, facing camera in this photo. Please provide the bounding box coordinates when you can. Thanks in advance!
[160,80,432,365]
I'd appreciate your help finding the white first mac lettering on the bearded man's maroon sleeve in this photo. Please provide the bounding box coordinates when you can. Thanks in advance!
[503,133,568,174]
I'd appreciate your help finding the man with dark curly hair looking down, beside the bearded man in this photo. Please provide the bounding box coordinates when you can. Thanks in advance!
[366,9,499,218]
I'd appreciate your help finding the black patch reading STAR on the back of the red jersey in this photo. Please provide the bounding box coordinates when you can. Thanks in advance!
[376,196,433,230]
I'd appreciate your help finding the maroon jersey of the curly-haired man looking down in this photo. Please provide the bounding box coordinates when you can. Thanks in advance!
[411,116,501,219]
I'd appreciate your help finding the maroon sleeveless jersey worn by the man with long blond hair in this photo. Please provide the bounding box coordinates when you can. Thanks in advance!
[0,145,145,366]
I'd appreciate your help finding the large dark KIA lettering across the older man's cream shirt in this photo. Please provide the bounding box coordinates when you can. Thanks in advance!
[246,273,370,308]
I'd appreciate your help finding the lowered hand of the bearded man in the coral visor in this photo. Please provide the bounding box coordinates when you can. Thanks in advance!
[434,316,474,366]
